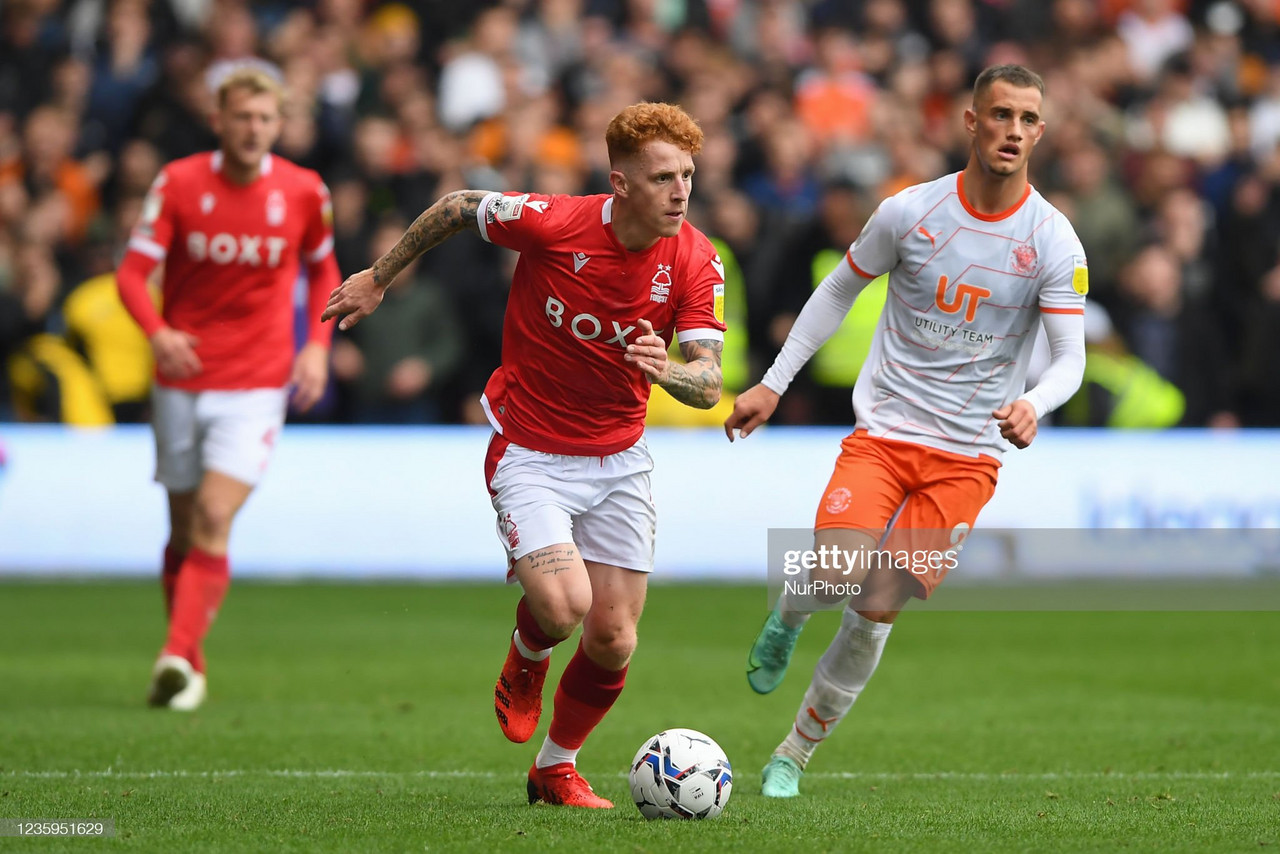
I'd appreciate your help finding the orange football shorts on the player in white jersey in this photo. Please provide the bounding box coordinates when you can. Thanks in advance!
[814,430,1000,599]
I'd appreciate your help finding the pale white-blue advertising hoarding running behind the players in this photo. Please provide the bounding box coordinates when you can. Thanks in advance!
[0,425,1280,580]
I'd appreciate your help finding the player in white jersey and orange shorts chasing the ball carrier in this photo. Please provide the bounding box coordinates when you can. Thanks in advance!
[724,65,1088,798]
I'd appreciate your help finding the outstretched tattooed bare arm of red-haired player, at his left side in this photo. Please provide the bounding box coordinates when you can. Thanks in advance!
[320,189,489,329]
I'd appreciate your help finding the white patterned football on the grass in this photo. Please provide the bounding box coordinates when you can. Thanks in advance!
[631,729,733,818]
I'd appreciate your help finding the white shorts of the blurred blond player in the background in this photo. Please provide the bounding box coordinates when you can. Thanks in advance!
[151,385,288,492]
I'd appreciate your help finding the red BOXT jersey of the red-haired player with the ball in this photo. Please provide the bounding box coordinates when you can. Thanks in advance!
[477,193,724,456]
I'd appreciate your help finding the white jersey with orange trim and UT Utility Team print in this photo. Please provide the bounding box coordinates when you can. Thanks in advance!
[846,173,1089,456]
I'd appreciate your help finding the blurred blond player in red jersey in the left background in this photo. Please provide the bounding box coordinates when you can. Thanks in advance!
[116,69,340,711]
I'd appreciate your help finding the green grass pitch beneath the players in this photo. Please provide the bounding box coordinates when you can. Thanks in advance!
[0,583,1280,854]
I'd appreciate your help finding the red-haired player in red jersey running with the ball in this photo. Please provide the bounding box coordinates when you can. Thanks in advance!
[324,104,724,808]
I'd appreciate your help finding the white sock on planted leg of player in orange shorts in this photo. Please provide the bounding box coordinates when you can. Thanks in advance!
[774,608,893,768]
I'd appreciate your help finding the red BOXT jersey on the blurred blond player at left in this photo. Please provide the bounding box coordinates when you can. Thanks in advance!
[120,151,333,391]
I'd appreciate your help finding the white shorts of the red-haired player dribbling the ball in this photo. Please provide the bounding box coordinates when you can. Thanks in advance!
[485,433,658,573]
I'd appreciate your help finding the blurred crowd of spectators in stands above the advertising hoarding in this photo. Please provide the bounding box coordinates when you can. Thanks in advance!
[0,0,1280,428]
